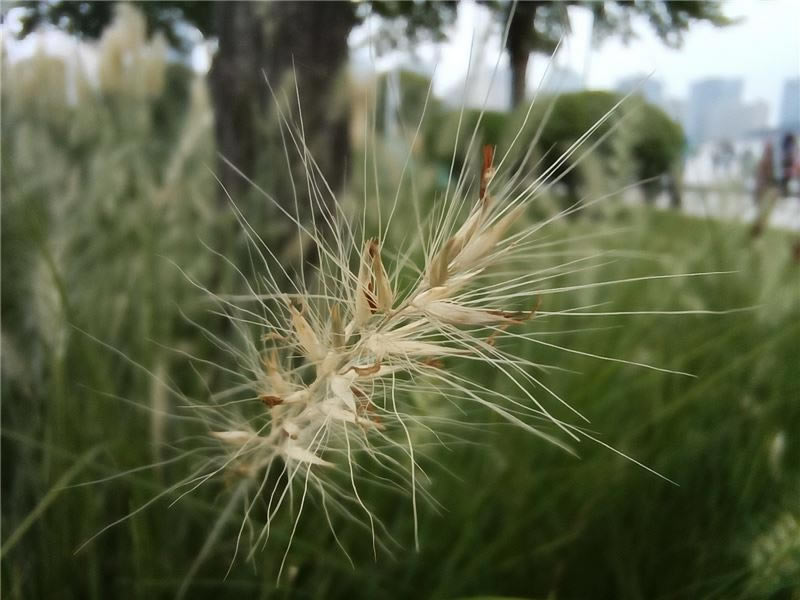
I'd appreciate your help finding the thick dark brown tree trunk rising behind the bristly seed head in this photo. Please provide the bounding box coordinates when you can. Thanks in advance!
[211,1,355,213]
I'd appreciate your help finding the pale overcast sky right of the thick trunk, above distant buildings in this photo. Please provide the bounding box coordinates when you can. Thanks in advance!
[368,0,800,123]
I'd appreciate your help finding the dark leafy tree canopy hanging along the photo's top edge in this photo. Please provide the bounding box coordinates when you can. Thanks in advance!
[15,0,732,106]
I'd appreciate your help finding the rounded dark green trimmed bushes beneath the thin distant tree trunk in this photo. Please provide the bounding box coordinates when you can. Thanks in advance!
[426,91,685,196]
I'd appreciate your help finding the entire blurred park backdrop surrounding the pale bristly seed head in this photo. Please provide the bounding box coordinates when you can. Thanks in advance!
[0,0,800,600]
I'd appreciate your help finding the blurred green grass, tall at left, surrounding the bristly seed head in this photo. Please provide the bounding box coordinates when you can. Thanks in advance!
[2,39,800,600]
